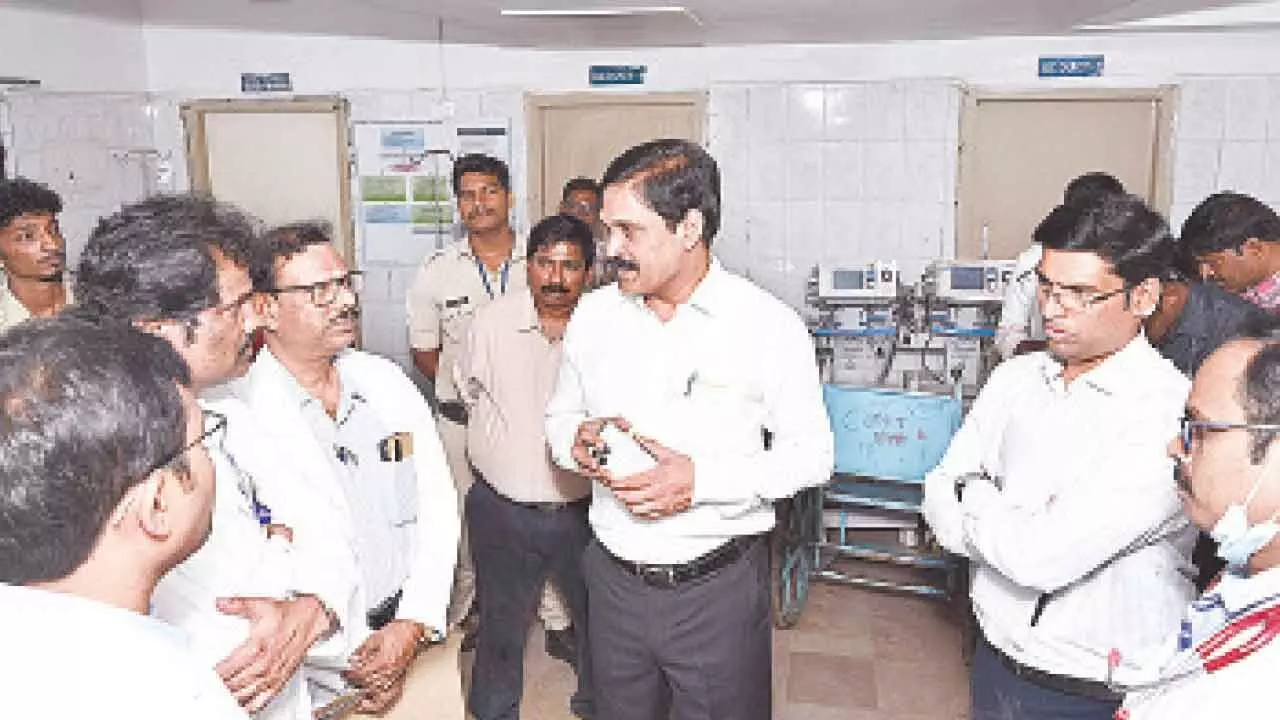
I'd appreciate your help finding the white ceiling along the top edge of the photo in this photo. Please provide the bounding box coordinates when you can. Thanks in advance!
[0,0,1249,46]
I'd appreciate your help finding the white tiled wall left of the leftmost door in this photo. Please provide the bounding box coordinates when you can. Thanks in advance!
[0,91,159,259]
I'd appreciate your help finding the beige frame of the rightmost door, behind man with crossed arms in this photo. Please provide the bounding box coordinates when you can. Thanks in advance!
[955,85,1178,258]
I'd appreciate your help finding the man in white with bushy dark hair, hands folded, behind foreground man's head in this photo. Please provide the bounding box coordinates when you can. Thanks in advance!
[69,195,352,720]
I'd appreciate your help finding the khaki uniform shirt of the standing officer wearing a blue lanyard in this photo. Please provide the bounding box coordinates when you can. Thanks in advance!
[406,237,529,401]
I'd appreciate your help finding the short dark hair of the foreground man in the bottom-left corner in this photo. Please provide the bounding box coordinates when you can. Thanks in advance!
[0,315,191,584]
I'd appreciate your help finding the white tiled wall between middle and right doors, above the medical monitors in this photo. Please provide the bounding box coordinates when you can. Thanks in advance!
[709,81,960,309]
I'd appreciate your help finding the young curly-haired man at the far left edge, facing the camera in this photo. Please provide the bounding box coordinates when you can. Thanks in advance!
[0,178,68,332]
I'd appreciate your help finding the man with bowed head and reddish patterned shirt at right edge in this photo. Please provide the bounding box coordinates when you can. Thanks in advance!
[1181,192,1280,315]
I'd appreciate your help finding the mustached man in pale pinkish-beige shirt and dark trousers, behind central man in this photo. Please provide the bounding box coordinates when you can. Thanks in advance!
[457,215,595,720]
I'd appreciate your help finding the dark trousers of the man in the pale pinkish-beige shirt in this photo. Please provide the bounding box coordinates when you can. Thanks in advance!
[466,478,594,720]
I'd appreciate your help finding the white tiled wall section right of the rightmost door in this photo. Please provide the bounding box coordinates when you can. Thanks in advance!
[1170,77,1280,229]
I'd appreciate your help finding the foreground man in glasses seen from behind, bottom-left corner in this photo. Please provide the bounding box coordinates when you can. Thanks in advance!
[0,316,247,720]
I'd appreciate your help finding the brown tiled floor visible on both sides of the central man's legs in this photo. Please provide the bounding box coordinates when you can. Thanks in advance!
[481,584,969,720]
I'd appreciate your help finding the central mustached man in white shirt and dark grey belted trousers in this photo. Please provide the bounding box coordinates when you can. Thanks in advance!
[547,140,833,720]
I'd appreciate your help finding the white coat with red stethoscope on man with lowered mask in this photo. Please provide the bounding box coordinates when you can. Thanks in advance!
[1117,568,1280,720]
